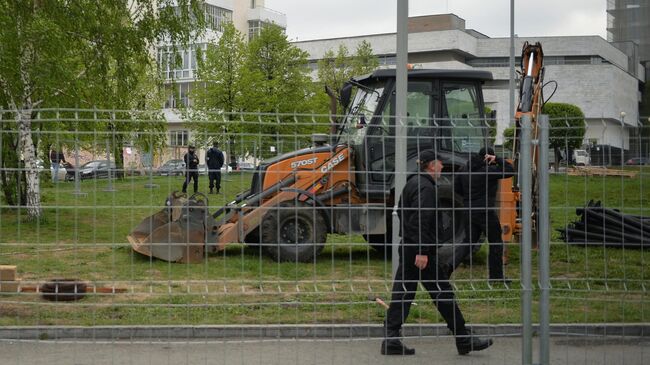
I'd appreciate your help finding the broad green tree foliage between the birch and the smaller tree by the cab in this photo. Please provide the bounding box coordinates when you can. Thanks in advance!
[191,25,326,160]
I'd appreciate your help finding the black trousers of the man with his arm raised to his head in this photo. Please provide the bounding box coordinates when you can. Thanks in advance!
[454,209,503,279]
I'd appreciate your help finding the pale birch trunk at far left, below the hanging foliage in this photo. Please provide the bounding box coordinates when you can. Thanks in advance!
[17,108,41,220]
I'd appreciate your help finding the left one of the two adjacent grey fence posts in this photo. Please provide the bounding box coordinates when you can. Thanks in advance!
[519,115,533,365]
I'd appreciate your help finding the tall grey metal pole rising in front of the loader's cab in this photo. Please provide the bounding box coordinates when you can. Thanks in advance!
[392,0,408,274]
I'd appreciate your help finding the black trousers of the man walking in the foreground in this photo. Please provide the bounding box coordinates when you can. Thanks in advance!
[386,255,465,337]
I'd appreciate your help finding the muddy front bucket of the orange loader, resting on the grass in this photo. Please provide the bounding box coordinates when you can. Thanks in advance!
[127,192,214,263]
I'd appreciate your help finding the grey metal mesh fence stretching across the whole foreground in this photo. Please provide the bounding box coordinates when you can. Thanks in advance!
[0,109,650,364]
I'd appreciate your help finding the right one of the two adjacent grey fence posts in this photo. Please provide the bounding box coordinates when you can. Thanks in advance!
[537,115,551,365]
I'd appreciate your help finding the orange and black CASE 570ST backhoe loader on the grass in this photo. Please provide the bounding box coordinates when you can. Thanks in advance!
[128,47,541,263]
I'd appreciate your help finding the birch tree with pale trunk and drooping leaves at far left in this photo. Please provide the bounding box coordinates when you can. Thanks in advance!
[0,0,203,219]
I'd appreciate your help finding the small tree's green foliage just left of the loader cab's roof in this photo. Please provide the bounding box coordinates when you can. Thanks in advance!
[318,41,379,113]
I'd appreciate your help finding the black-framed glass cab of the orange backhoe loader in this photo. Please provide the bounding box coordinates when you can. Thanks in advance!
[338,69,492,200]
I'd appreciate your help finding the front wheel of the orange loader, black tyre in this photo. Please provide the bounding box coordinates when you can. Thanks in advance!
[260,200,327,262]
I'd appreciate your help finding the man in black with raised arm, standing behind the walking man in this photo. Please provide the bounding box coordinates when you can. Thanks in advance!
[453,147,515,282]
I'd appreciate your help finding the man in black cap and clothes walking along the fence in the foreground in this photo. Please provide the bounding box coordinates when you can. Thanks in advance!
[381,150,492,355]
